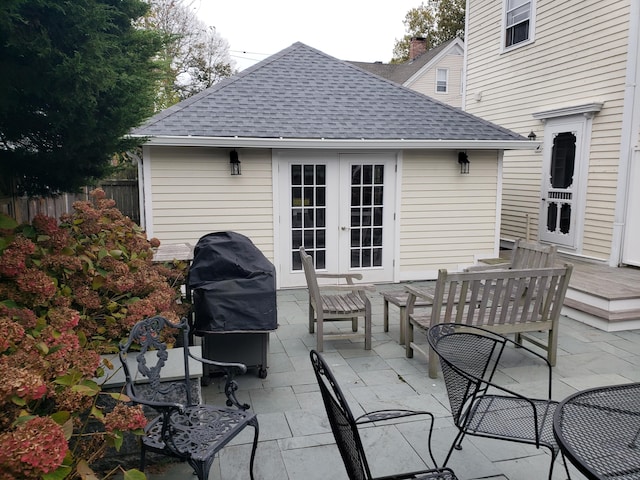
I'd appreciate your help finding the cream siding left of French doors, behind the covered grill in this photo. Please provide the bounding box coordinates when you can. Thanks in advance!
[147,147,273,259]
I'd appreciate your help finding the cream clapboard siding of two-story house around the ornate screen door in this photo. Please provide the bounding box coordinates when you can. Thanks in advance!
[465,0,630,259]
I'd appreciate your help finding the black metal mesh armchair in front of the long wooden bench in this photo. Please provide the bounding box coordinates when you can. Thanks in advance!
[427,323,570,479]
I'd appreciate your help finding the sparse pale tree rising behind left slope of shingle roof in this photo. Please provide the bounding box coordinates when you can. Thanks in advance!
[143,0,235,110]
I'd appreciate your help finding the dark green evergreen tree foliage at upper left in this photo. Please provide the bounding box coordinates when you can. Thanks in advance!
[0,0,162,195]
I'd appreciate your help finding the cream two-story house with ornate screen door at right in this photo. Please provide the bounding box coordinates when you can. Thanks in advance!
[463,0,640,330]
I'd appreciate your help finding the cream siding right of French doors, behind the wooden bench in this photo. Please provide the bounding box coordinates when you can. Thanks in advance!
[399,151,499,281]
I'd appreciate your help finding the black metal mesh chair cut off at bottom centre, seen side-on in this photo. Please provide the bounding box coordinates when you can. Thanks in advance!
[310,350,457,480]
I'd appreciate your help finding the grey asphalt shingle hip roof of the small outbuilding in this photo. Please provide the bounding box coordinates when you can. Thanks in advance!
[132,42,526,141]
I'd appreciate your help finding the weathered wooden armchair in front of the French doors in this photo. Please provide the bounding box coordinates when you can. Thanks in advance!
[300,247,373,352]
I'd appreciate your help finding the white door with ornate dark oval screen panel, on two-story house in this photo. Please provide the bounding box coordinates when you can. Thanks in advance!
[540,119,586,249]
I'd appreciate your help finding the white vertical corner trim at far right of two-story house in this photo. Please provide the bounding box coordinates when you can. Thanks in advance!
[609,0,640,267]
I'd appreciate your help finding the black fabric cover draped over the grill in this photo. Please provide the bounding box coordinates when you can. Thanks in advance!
[188,232,278,335]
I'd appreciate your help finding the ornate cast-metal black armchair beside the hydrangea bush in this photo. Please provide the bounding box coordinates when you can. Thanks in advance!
[120,316,258,480]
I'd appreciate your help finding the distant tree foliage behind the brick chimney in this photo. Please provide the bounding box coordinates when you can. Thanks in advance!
[391,0,465,63]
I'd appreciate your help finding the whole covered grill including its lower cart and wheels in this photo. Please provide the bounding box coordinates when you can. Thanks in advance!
[187,232,278,384]
